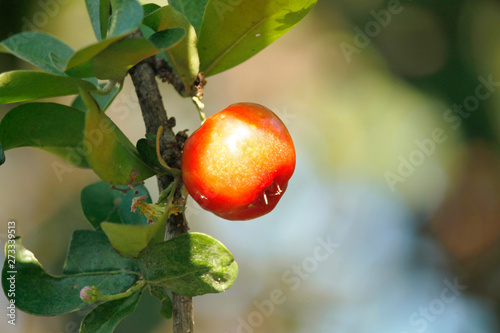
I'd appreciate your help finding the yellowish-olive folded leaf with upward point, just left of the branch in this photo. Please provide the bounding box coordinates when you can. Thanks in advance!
[81,90,155,185]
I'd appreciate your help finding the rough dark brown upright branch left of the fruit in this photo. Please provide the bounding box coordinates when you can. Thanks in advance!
[130,32,194,333]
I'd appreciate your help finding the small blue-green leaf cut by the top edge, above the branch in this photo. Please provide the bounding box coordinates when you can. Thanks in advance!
[108,0,144,37]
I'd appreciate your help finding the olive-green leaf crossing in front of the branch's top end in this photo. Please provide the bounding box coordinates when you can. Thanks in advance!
[92,29,185,80]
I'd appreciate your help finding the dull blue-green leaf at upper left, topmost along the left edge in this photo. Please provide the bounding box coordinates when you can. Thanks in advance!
[0,31,74,75]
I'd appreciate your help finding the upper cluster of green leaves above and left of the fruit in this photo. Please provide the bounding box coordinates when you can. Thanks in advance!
[0,0,316,185]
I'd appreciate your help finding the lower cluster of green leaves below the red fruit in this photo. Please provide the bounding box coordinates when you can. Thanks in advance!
[2,182,238,332]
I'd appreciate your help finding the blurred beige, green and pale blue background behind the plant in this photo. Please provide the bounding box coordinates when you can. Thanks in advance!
[0,0,500,333]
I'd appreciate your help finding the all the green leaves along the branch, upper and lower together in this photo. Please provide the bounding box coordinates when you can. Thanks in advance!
[0,0,316,332]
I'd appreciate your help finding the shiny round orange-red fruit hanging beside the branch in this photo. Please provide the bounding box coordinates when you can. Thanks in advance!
[182,103,296,220]
